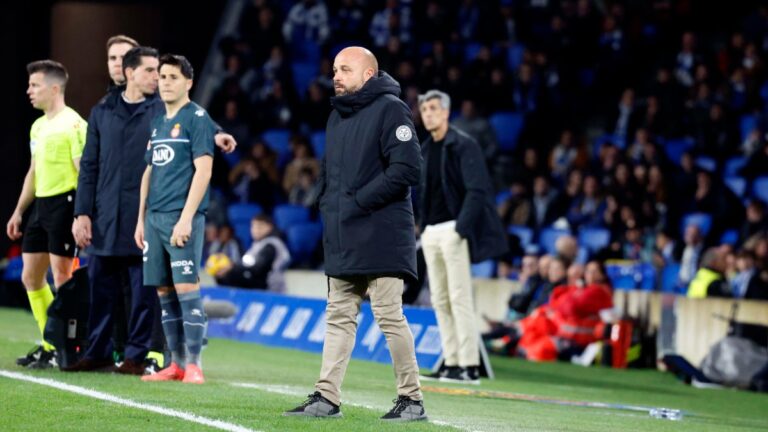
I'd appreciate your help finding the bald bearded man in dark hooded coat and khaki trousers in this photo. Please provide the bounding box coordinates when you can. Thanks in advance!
[284,47,427,421]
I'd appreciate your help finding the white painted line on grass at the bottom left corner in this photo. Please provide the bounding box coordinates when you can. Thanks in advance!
[0,369,259,432]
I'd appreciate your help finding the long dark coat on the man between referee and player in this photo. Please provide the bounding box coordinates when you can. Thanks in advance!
[75,87,165,256]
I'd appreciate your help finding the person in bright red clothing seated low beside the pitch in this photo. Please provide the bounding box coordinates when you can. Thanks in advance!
[517,261,613,361]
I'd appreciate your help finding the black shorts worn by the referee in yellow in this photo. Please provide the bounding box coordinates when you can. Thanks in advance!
[21,190,75,257]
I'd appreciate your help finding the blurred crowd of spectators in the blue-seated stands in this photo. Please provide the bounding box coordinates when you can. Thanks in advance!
[194,0,768,298]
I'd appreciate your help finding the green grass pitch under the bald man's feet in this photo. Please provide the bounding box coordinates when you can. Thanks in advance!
[0,308,768,432]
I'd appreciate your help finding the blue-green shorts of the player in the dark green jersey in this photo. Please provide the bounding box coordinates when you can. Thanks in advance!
[144,211,205,286]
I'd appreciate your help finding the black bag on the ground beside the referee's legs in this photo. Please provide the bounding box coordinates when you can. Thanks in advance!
[45,267,90,368]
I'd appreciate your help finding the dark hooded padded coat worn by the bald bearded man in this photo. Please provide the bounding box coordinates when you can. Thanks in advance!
[319,72,421,279]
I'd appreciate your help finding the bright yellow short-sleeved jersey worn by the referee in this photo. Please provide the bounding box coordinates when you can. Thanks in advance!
[29,107,88,198]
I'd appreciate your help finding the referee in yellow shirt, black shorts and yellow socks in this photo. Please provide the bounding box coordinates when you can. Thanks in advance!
[6,60,87,369]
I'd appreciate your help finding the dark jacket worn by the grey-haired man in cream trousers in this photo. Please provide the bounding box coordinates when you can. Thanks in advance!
[419,126,509,263]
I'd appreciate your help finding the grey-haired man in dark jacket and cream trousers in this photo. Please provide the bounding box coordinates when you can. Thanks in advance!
[419,90,507,384]
